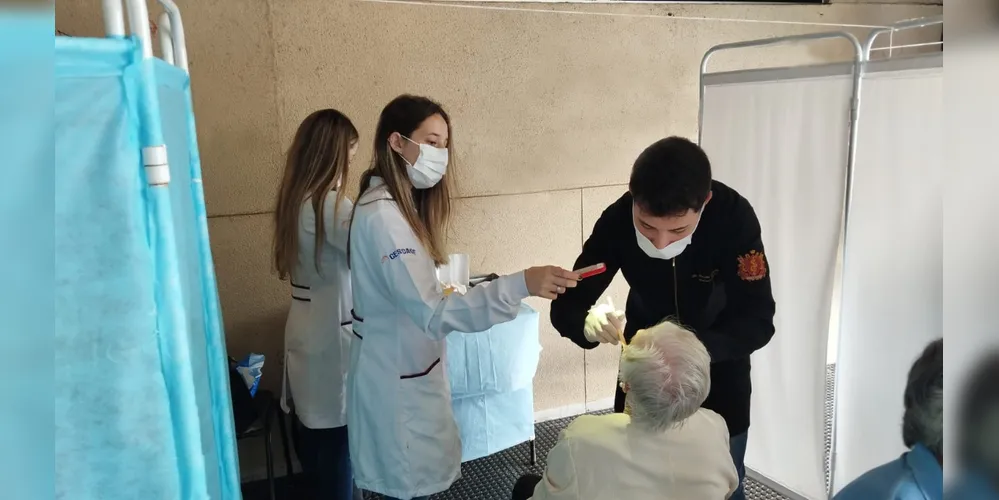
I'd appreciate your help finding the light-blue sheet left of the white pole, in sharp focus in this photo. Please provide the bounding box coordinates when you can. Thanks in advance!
[54,40,181,499]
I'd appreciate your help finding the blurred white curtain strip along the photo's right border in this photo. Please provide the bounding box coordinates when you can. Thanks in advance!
[943,46,999,478]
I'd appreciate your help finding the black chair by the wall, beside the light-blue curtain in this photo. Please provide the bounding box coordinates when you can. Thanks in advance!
[229,358,293,500]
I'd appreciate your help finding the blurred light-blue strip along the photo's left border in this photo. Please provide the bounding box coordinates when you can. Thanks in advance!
[0,12,55,499]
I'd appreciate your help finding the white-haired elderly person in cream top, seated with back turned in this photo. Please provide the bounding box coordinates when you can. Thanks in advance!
[513,322,739,500]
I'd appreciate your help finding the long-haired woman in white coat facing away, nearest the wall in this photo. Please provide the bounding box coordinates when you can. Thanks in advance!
[274,109,358,500]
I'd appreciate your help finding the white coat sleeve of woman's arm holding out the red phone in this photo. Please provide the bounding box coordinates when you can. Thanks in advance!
[365,210,530,340]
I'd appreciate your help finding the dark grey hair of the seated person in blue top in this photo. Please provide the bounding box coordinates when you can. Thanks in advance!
[902,339,944,458]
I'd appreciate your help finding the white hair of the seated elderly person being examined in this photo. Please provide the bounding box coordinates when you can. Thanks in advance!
[620,321,711,431]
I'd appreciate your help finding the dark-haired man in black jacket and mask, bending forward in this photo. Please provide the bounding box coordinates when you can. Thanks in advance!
[551,137,776,500]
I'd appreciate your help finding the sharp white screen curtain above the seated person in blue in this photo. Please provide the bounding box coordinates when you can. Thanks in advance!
[834,68,948,491]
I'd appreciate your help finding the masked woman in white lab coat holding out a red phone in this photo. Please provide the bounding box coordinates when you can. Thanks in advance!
[347,96,578,500]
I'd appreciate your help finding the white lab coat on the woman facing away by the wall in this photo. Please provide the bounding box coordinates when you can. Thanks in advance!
[281,192,353,429]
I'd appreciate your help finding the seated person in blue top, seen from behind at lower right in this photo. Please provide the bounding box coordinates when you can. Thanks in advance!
[834,339,943,500]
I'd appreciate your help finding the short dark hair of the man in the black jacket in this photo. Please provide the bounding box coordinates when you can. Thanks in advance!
[628,137,711,217]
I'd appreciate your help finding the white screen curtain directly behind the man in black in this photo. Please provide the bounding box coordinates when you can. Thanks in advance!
[701,76,851,498]
